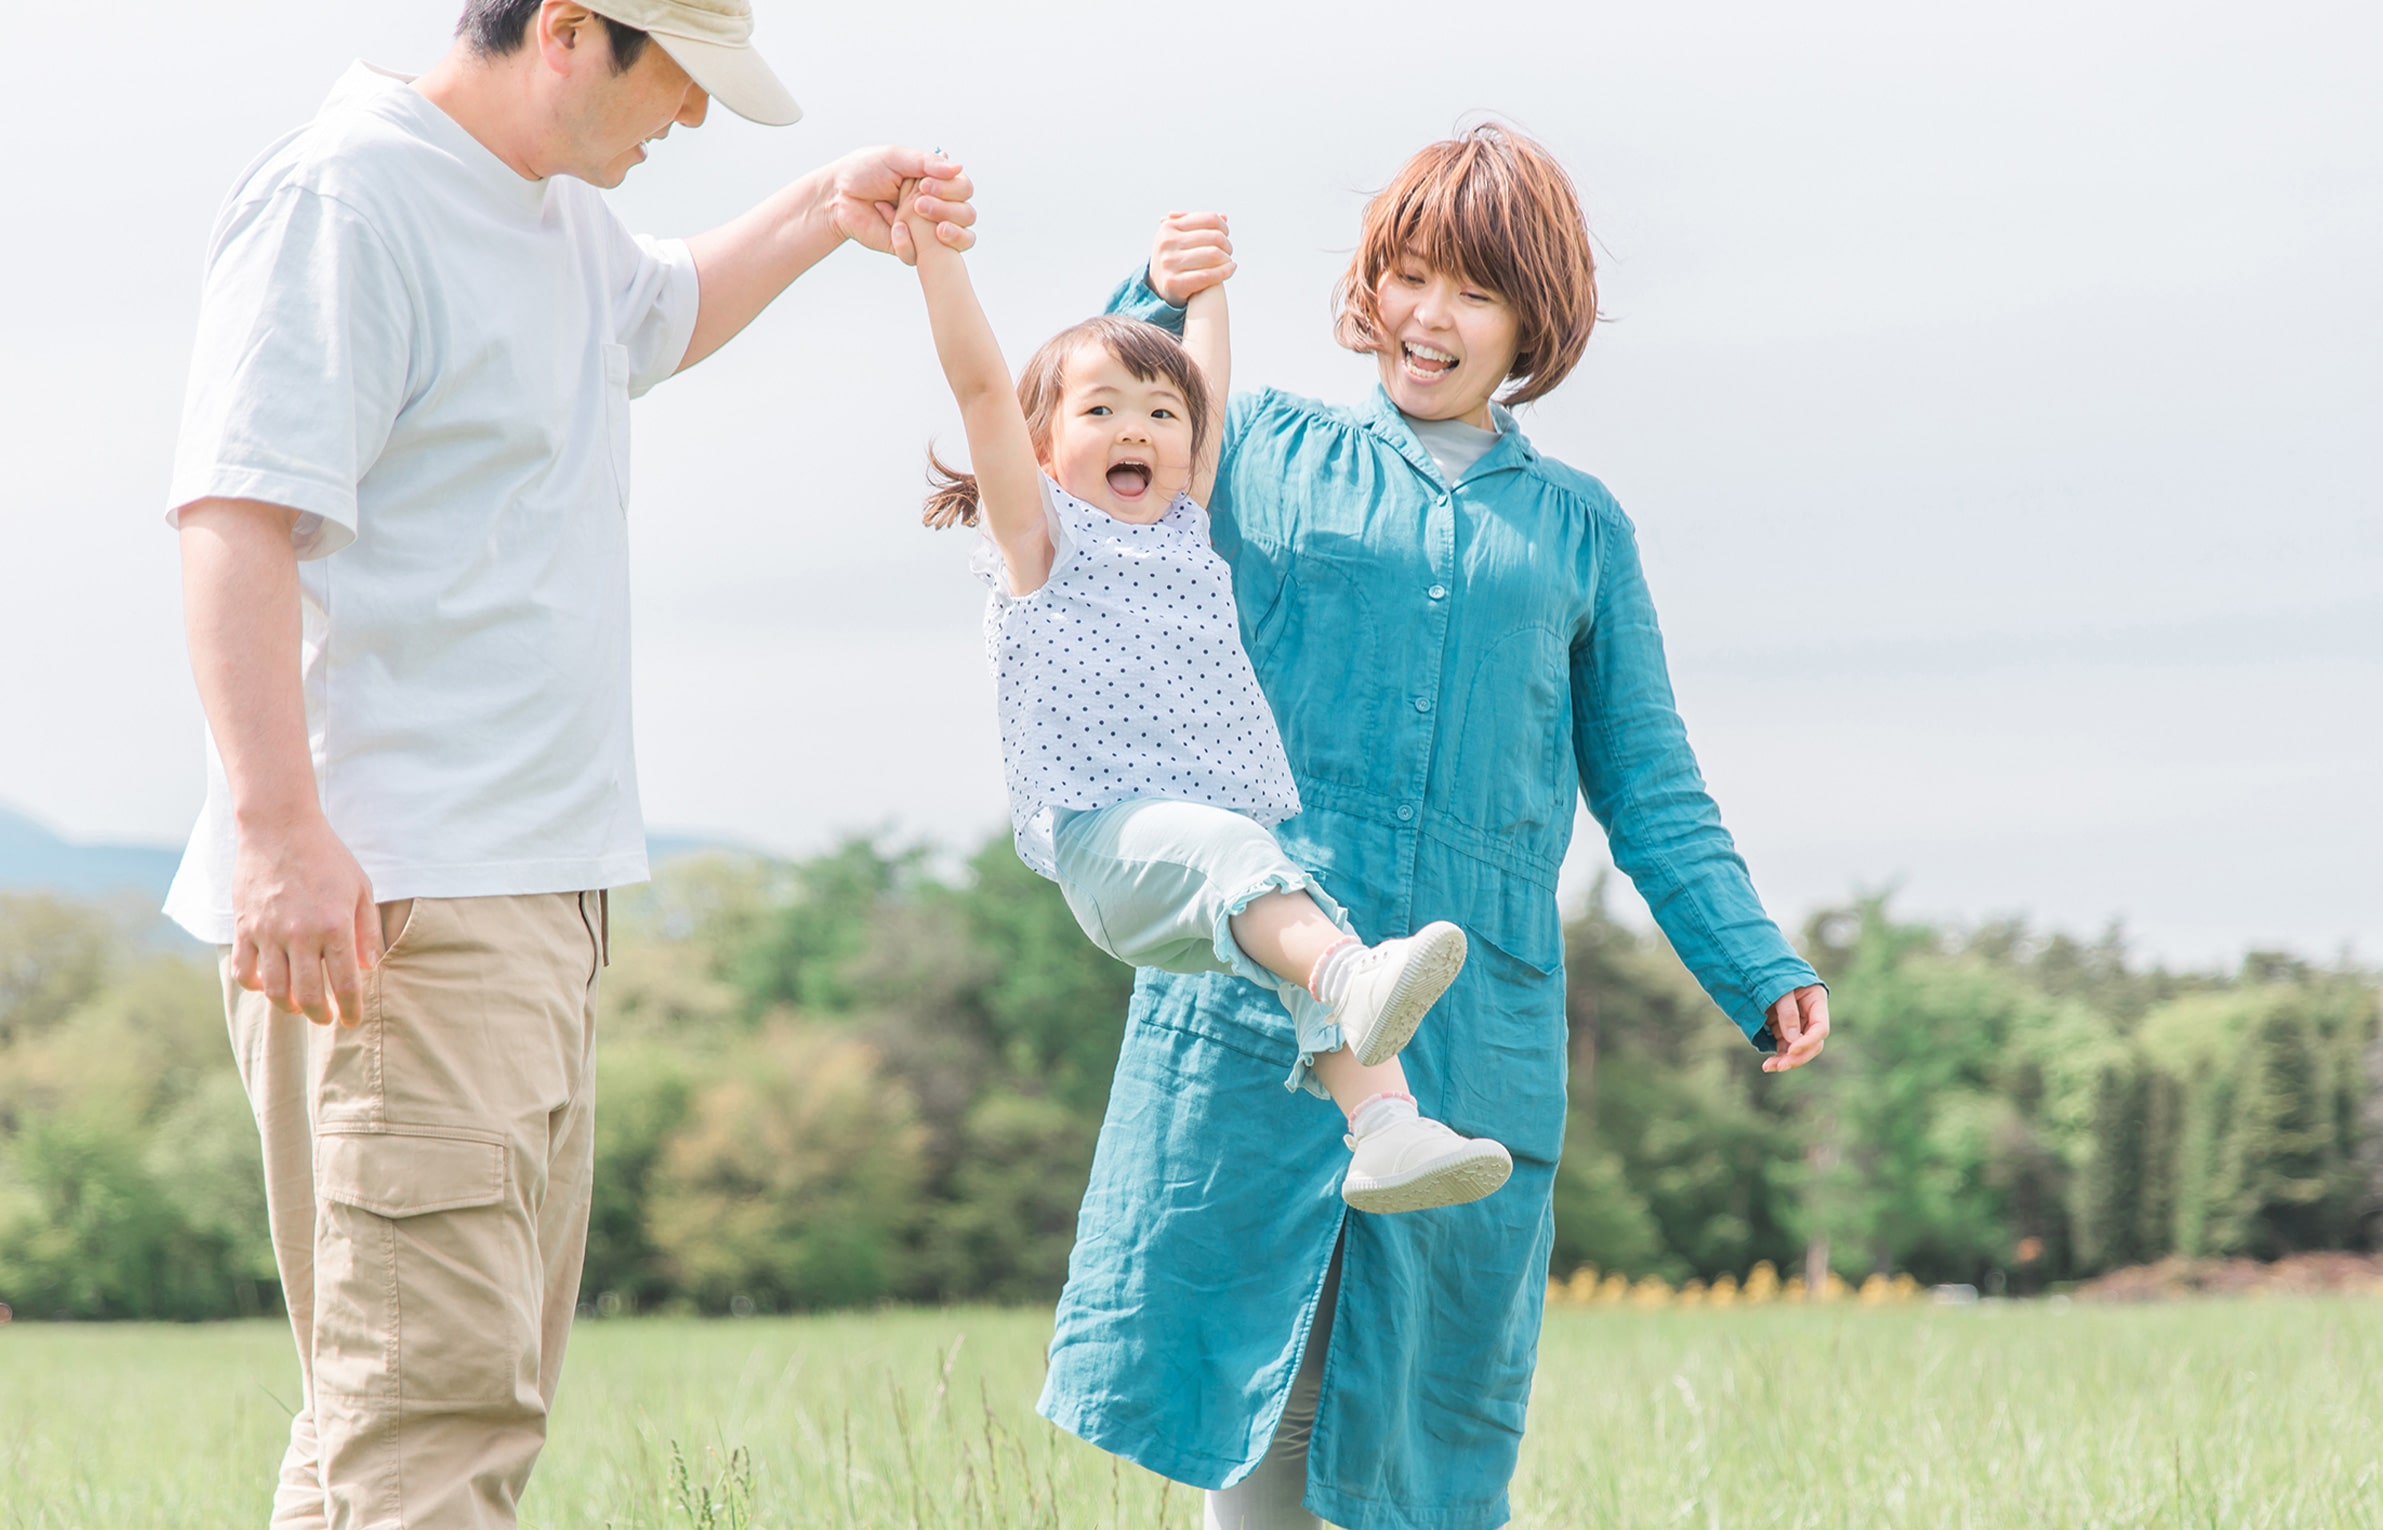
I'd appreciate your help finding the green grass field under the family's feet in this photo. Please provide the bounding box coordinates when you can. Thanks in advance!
[0,1299,2383,1530]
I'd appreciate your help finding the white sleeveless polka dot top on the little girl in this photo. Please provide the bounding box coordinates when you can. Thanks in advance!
[970,477,1299,877]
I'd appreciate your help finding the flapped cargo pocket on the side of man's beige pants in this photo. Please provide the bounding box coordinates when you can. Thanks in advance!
[315,1122,521,1406]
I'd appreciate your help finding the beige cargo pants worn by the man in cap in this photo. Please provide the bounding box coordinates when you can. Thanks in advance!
[224,891,605,1530]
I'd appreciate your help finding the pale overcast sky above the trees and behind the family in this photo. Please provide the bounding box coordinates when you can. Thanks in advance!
[0,0,2383,960]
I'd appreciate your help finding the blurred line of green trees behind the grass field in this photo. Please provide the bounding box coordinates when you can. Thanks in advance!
[0,839,2383,1318]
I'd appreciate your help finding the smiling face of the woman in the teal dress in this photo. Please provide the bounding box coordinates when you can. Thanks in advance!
[1373,253,1520,429]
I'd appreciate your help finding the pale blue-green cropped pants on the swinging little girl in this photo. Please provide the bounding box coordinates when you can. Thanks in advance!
[1051,798,1356,1096]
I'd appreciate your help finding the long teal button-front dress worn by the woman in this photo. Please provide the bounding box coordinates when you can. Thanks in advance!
[1039,279,1818,1530]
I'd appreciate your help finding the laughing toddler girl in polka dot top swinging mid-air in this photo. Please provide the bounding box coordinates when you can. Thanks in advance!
[896,193,1513,1211]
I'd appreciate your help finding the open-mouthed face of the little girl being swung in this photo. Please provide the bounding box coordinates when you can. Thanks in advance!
[1044,346,1192,524]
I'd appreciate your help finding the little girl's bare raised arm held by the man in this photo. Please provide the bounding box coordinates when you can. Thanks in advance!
[896,186,1053,583]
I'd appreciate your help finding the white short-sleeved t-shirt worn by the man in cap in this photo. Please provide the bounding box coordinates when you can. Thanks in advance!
[167,64,696,944]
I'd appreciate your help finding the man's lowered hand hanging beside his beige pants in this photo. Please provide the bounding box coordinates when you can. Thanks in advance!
[231,815,381,1025]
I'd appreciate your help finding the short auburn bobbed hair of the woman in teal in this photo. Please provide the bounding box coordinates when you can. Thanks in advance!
[1332,124,1597,405]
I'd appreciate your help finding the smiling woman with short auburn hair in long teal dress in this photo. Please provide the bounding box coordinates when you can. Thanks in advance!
[1041,129,1828,1530]
